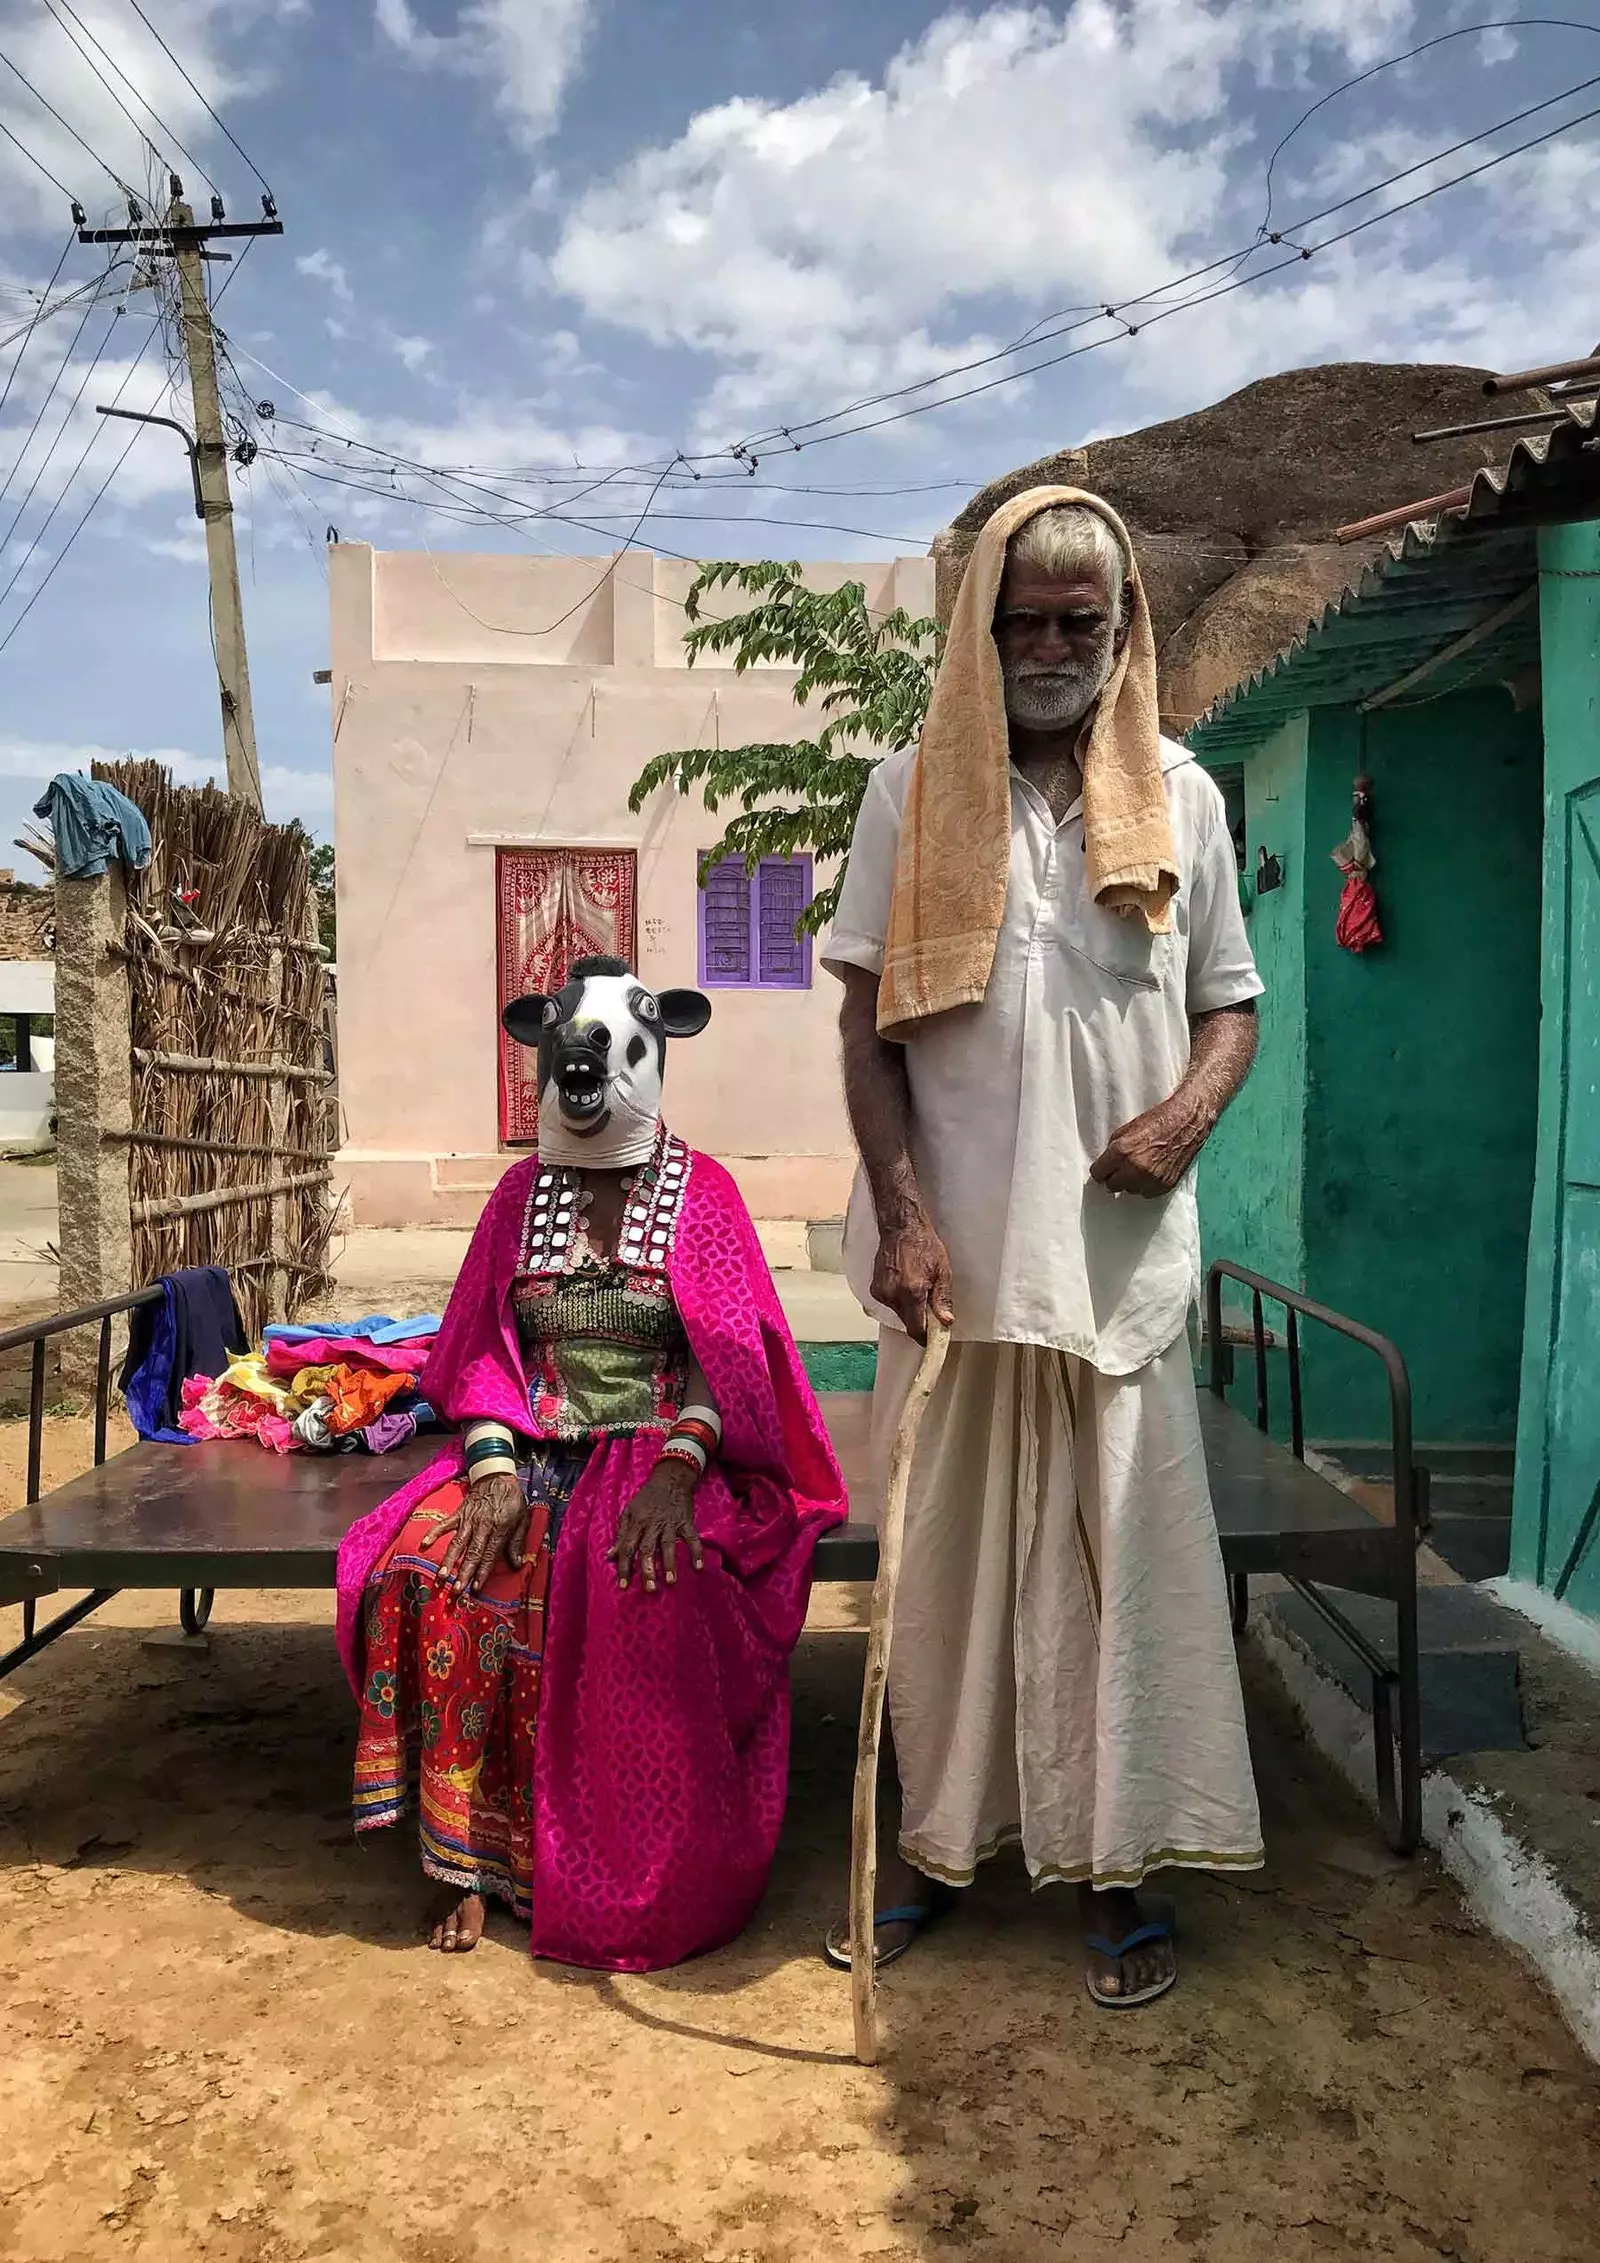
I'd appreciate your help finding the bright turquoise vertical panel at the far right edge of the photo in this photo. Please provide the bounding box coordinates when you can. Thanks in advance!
[1512,523,1600,1616]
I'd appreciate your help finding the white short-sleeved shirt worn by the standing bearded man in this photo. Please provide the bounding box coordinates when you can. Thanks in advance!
[821,738,1261,1376]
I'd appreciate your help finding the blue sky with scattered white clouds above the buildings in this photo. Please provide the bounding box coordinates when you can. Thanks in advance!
[0,0,1600,869]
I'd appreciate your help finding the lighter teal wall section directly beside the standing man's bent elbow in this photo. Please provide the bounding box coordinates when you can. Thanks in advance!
[1199,715,1306,1301]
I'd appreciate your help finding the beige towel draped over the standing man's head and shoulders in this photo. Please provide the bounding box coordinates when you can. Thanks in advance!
[878,487,1179,1039]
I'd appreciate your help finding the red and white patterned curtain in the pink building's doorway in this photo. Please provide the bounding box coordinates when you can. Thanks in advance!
[496,849,638,1147]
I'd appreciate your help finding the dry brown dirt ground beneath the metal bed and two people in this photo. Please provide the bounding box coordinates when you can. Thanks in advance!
[0,1423,1600,2263]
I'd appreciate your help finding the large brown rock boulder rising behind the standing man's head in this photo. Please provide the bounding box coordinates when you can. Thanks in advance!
[932,362,1548,733]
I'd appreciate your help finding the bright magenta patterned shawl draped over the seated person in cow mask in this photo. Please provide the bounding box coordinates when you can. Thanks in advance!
[339,1154,844,1971]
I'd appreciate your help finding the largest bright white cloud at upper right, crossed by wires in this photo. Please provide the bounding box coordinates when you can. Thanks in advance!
[547,0,1593,446]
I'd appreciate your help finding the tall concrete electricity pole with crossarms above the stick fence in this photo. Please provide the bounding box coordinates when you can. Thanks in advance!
[79,174,283,810]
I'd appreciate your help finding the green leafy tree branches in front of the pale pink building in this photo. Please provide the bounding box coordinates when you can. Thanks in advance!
[627,559,939,932]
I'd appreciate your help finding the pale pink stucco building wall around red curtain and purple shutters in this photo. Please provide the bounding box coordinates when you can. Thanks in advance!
[330,543,932,1227]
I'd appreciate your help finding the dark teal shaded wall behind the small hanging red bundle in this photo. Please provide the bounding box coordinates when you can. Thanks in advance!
[1306,686,1543,1444]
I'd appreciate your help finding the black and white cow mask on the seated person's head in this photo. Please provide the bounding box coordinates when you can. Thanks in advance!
[500,960,711,1170]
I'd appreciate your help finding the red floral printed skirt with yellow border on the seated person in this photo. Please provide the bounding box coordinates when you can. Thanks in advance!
[355,1446,591,1921]
